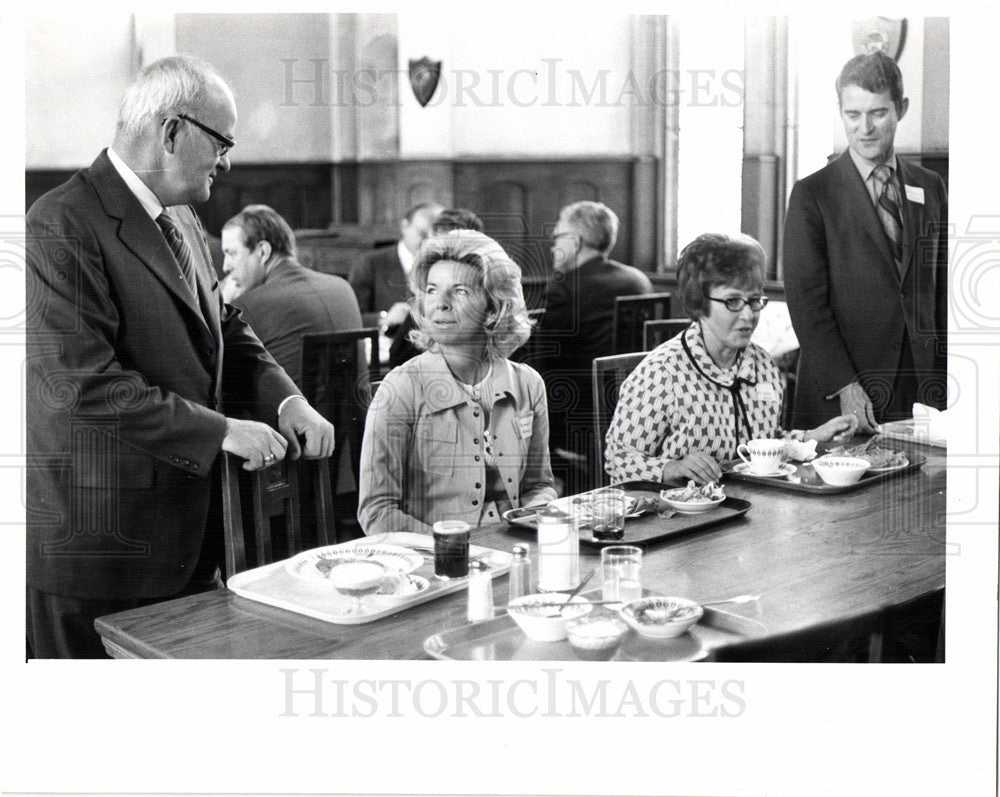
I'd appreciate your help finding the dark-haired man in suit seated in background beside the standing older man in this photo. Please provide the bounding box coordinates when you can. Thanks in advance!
[222,205,362,386]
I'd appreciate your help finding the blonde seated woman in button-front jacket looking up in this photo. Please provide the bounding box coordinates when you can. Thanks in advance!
[358,230,556,534]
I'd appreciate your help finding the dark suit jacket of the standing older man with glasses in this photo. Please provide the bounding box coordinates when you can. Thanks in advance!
[26,152,299,601]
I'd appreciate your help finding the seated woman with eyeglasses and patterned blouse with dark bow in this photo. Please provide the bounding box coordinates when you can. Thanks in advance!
[605,233,857,483]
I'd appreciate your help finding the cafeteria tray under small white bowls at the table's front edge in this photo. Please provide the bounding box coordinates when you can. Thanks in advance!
[424,606,765,661]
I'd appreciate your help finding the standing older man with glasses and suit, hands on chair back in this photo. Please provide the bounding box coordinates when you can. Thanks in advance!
[26,57,333,657]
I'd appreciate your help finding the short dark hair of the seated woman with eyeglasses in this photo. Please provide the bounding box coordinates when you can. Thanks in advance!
[677,232,767,319]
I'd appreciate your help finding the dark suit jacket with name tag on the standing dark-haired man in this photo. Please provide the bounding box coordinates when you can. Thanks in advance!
[784,152,948,427]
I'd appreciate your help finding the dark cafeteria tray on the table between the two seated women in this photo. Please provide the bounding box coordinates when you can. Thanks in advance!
[503,481,750,548]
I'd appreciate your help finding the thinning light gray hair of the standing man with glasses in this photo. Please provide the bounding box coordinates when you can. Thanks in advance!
[116,55,225,139]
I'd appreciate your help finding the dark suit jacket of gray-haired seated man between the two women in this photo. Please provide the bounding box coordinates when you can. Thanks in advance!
[536,257,653,456]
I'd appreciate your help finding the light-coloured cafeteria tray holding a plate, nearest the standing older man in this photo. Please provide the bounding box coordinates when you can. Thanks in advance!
[226,532,511,625]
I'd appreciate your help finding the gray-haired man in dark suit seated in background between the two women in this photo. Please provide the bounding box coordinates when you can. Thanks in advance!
[538,202,653,494]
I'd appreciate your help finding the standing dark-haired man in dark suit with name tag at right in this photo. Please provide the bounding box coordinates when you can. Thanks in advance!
[784,52,948,431]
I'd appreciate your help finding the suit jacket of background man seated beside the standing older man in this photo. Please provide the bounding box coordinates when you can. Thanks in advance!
[232,257,362,385]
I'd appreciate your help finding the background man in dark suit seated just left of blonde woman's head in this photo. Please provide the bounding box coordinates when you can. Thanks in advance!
[347,202,441,320]
